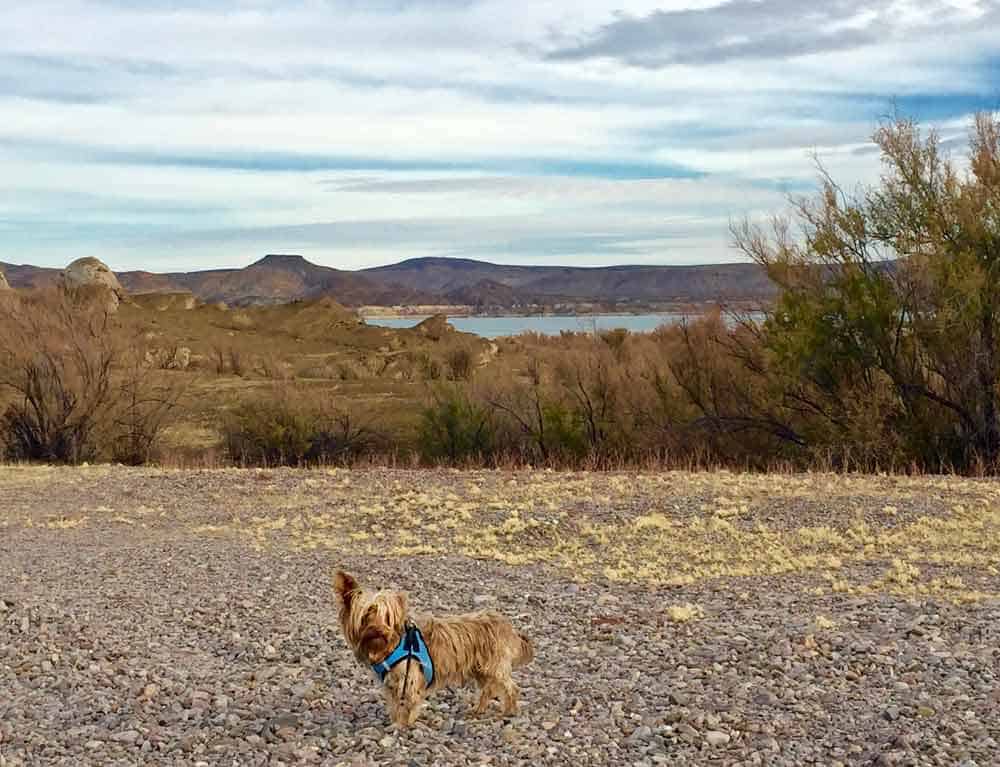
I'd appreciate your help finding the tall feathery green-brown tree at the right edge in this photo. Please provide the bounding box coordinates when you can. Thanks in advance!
[734,114,1000,468]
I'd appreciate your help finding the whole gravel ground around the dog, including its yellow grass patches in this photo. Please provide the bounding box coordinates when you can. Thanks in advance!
[0,467,1000,767]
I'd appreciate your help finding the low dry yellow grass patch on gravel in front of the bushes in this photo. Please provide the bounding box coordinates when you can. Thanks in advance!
[45,468,984,608]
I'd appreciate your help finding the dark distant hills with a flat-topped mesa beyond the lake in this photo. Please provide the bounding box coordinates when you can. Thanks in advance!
[0,255,775,308]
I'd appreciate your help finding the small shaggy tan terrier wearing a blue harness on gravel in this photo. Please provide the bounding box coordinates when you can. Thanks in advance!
[333,571,534,727]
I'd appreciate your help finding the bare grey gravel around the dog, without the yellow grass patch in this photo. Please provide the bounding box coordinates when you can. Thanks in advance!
[0,468,1000,767]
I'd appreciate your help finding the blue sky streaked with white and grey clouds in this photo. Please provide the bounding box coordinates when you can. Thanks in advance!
[0,0,1000,271]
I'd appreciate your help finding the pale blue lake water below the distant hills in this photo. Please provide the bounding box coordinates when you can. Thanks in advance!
[365,314,691,338]
